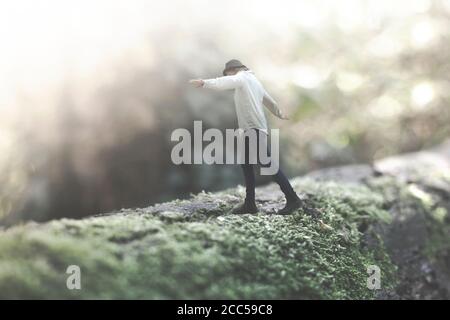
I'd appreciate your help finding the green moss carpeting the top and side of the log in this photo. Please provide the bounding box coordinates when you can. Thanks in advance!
[0,179,395,299]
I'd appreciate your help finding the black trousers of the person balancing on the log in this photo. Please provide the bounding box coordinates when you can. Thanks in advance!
[241,129,297,203]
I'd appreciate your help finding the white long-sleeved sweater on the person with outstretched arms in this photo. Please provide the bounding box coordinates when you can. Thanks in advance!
[203,70,281,133]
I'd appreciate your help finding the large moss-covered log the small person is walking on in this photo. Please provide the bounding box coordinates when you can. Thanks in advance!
[0,144,450,299]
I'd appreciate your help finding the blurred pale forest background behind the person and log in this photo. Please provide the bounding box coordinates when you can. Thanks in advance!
[0,0,450,224]
